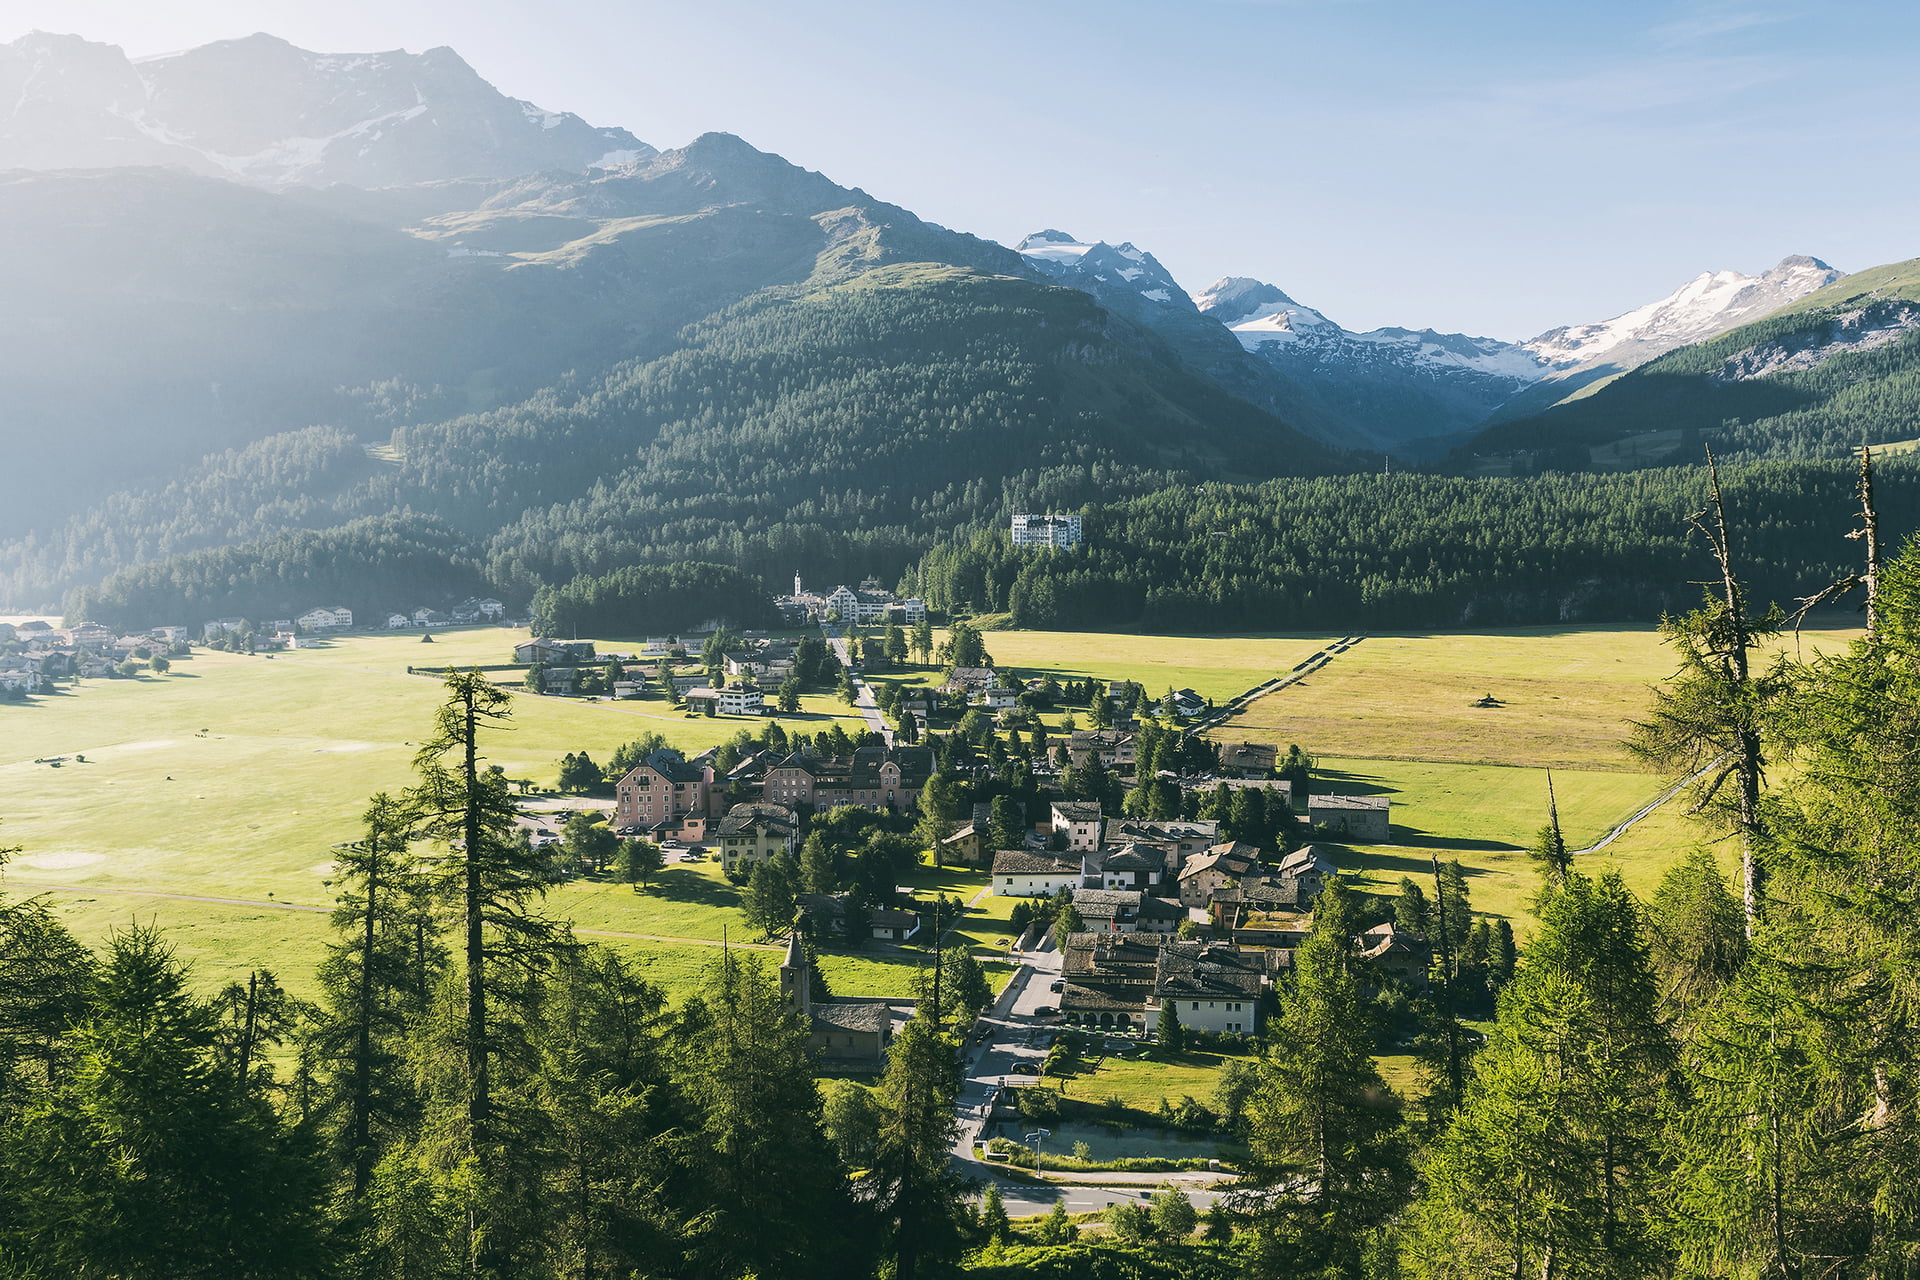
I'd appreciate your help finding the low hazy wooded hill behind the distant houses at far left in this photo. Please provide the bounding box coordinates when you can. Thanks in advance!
[67,516,488,628]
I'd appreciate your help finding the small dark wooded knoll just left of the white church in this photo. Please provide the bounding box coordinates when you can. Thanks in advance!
[532,562,780,635]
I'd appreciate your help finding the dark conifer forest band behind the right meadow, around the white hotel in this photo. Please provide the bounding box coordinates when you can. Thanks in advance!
[910,459,1920,631]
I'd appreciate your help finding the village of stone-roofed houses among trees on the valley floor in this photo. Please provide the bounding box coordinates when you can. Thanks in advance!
[495,581,1432,1069]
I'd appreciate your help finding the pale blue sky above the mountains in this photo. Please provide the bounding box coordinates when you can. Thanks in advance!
[0,0,1920,340]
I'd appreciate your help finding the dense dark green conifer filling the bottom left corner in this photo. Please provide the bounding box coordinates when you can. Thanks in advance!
[0,927,326,1280]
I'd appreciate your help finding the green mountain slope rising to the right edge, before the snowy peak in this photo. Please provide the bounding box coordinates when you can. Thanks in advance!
[1471,259,1920,466]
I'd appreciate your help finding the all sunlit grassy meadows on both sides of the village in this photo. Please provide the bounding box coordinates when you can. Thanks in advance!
[0,628,1847,990]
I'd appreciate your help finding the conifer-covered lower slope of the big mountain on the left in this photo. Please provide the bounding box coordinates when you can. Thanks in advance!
[33,265,1342,626]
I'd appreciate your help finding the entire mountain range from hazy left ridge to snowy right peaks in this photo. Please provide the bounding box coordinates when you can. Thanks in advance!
[0,35,1910,629]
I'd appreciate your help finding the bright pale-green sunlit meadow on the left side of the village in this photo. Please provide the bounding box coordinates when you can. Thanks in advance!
[0,628,864,990]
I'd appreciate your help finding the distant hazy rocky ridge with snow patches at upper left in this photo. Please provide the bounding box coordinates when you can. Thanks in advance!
[0,31,655,186]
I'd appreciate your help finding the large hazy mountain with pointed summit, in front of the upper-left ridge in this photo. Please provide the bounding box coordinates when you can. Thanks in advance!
[0,42,1342,620]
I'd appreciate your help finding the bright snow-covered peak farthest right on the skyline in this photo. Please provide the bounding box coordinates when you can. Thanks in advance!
[1523,255,1843,368]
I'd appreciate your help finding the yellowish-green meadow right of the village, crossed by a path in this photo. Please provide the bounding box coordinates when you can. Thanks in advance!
[1215,626,1857,935]
